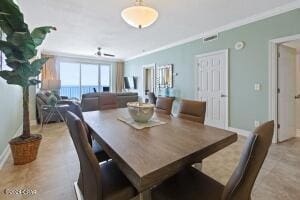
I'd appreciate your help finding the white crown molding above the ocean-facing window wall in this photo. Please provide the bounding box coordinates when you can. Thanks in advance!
[41,50,124,62]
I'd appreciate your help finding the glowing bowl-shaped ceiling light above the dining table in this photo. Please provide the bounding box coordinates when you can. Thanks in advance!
[121,0,158,29]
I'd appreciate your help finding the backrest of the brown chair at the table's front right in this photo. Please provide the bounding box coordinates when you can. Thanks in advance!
[222,121,274,200]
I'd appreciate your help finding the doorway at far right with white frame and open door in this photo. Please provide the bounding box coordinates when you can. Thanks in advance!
[269,35,300,143]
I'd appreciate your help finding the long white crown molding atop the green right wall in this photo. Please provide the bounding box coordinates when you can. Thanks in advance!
[125,0,300,61]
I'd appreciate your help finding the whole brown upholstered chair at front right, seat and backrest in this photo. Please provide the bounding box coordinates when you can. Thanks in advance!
[152,121,274,200]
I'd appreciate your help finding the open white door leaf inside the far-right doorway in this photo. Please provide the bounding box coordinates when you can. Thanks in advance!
[278,45,296,142]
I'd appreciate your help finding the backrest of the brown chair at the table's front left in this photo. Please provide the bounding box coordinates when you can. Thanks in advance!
[66,111,102,200]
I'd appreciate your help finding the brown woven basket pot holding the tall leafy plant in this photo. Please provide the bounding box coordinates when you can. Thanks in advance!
[9,134,42,165]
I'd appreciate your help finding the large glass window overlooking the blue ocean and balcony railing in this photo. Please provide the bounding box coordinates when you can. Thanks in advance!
[60,62,111,99]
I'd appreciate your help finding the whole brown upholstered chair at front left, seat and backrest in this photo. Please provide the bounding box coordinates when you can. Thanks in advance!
[66,112,137,200]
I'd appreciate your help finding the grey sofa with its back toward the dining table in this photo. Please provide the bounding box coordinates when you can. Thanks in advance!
[81,92,138,112]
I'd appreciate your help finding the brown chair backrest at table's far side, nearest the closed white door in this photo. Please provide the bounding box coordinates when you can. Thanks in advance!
[178,99,206,124]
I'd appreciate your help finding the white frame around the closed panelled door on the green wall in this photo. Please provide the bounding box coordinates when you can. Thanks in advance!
[194,49,229,129]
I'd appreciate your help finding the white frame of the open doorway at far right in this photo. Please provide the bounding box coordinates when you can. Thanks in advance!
[268,34,300,143]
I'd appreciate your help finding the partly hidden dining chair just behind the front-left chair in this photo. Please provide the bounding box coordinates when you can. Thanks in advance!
[69,103,110,162]
